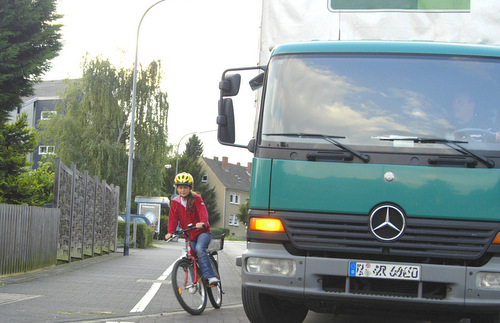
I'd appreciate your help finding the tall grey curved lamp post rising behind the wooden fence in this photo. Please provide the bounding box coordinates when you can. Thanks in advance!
[123,0,165,256]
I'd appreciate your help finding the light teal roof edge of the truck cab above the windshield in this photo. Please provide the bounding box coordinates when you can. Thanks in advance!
[272,41,500,57]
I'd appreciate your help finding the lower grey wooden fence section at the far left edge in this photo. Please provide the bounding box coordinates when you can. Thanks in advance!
[0,204,60,276]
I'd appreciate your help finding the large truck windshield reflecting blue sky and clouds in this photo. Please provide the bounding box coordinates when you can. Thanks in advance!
[260,54,500,154]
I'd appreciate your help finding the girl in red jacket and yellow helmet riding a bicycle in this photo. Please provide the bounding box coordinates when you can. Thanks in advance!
[165,173,219,285]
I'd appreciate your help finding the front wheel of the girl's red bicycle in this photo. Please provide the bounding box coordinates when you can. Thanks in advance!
[172,259,207,315]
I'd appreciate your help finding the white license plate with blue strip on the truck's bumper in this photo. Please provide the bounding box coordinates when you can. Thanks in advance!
[349,261,421,280]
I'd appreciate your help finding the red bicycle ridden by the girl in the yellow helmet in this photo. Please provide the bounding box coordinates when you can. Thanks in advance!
[167,224,224,315]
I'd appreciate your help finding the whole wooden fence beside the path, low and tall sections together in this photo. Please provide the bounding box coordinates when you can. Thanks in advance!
[0,158,120,276]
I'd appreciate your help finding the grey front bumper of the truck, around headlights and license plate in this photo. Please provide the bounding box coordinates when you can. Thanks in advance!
[241,242,500,312]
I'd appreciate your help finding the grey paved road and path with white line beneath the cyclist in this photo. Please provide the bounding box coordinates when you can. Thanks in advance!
[0,241,434,323]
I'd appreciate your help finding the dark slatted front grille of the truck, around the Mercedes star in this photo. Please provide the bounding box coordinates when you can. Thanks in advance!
[276,212,500,260]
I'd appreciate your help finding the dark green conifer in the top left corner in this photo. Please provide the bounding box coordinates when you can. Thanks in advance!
[0,0,62,123]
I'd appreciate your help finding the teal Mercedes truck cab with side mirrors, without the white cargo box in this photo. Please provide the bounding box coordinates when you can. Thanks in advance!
[217,41,500,322]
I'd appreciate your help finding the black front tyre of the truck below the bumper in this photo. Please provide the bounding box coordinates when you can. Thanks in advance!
[241,287,309,323]
